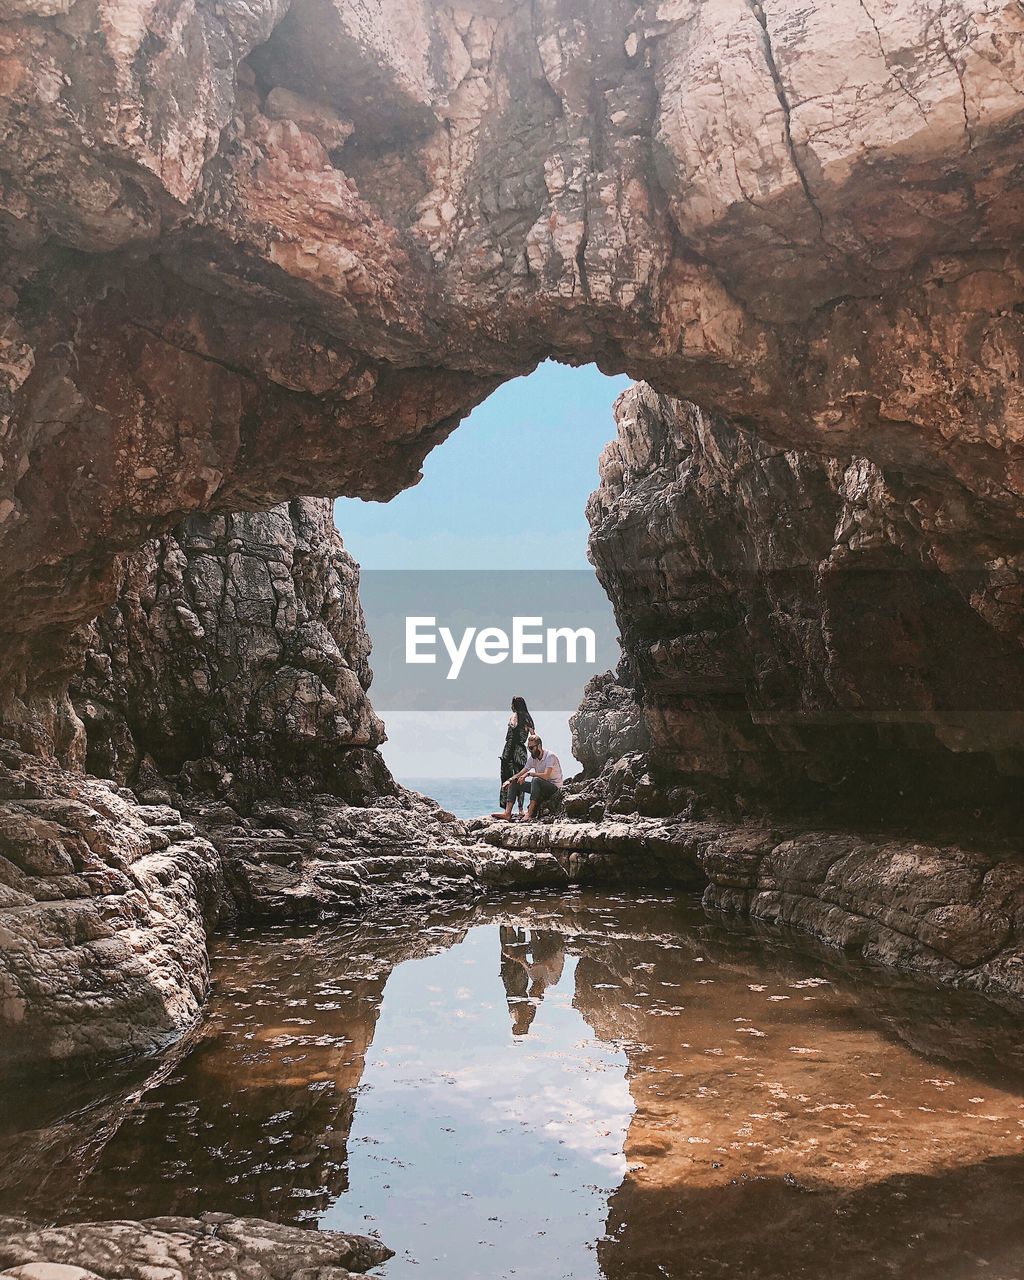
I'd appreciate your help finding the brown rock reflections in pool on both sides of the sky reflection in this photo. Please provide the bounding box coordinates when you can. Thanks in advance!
[10,893,1024,1280]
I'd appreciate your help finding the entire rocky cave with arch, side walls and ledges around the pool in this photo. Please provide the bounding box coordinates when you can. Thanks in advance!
[0,0,1024,1280]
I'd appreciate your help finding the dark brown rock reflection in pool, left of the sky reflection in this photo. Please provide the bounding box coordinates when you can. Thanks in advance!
[0,913,471,1222]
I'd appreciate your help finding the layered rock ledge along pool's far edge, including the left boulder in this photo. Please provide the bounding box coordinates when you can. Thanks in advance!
[0,727,1024,1066]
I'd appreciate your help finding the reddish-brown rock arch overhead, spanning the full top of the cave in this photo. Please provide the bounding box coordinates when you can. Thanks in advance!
[0,0,1024,750]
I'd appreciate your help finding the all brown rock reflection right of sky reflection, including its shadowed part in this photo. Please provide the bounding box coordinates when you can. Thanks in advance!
[488,900,1024,1280]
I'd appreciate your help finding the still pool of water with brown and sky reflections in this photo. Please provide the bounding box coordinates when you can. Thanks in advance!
[0,893,1024,1280]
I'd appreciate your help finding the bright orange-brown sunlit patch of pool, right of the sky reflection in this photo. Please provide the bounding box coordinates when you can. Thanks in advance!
[575,936,1024,1198]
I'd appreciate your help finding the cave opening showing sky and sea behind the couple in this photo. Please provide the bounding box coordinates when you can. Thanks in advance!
[334,361,631,818]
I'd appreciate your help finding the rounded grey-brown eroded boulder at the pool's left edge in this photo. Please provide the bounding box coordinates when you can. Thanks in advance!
[0,742,221,1068]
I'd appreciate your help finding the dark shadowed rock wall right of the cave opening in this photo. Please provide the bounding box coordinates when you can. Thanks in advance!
[579,385,1024,829]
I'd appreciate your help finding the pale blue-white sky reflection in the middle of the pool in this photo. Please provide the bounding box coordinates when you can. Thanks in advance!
[321,925,632,1280]
